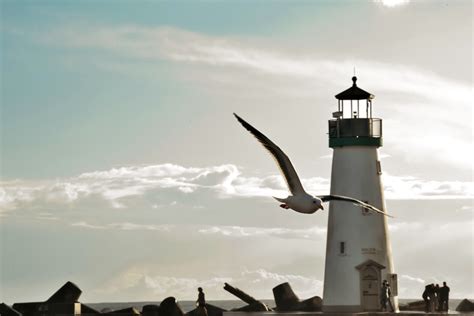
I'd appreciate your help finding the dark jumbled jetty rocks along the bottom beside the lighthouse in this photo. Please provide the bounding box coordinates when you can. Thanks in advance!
[4,282,474,316]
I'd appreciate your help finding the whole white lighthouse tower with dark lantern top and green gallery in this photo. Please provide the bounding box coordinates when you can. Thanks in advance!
[323,77,398,312]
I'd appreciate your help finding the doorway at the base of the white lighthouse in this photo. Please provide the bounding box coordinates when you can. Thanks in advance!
[360,266,380,311]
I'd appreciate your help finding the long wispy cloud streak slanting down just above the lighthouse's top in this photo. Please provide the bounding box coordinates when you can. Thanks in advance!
[48,25,471,105]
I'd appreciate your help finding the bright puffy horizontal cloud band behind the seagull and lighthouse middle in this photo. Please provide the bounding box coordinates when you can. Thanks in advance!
[0,163,474,211]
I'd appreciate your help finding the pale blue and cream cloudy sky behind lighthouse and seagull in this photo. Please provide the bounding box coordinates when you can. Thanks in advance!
[0,0,474,304]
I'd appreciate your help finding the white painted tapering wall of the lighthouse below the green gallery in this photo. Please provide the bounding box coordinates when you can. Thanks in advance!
[323,146,398,310]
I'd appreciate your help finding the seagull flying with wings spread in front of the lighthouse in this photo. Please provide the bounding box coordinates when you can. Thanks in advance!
[234,113,392,217]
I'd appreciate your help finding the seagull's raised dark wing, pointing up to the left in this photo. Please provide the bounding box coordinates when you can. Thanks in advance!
[234,113,305,195]
